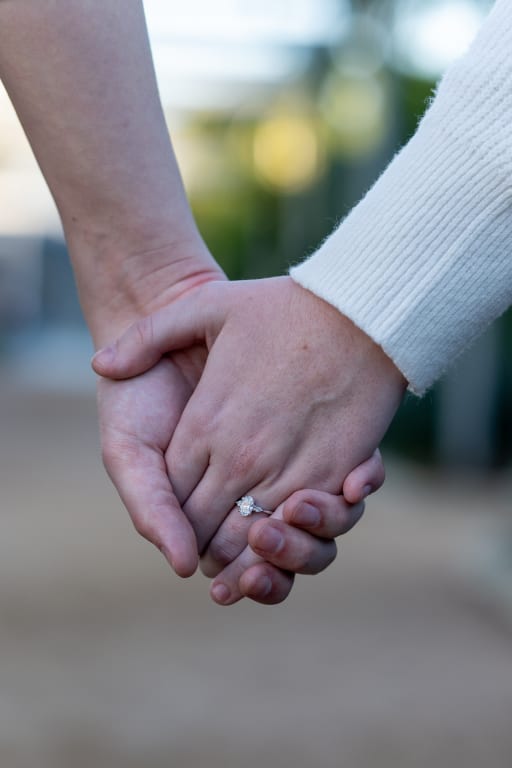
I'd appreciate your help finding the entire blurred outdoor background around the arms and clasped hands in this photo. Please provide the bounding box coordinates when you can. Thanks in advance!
[0,0,512,768]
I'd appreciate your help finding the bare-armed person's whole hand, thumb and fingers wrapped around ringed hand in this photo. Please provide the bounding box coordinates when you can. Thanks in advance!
[98,340,384,604]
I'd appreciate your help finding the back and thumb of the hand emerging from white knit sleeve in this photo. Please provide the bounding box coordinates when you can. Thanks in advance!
[93,278,405,551]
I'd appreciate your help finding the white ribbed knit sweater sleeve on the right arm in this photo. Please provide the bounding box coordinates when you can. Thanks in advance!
[290,0,512,393]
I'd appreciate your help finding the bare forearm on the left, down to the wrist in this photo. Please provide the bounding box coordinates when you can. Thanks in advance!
[0,0,222,344]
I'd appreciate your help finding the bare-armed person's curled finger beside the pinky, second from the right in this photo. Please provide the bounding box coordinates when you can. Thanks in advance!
[280,490,364,543]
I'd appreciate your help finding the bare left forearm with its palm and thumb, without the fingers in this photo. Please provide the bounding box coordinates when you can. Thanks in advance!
[0,0,392,604]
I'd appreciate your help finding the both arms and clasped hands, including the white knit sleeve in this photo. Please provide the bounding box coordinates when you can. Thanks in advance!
[0,0,512,604]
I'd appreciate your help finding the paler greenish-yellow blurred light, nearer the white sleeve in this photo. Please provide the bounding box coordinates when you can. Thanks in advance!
[322,74,386,157]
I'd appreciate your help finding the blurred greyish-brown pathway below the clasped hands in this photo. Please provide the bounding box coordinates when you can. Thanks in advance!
[0,385,512,768]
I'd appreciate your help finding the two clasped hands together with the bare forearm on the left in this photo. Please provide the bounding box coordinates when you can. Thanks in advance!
[0,0,405,604]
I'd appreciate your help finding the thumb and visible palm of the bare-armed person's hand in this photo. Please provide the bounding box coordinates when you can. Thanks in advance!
[98,348,204,576]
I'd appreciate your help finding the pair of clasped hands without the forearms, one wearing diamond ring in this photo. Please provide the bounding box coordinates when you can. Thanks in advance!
[93,278,403,603]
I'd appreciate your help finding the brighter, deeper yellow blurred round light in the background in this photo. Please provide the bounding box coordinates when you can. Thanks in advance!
[253,115,321,192]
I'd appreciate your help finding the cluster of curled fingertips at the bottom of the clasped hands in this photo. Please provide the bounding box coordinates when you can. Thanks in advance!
[206,451,384,605]
